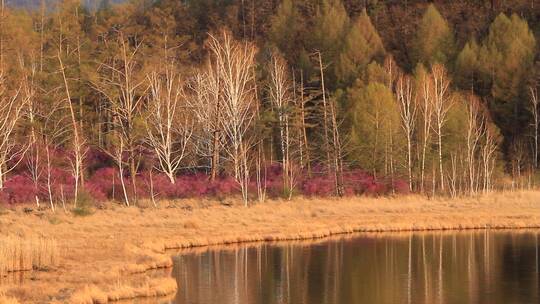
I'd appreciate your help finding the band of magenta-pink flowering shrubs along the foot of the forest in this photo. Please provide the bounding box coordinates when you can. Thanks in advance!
[0,149,408,204]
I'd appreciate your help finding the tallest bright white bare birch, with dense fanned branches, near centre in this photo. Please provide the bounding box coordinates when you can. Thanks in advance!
[209,31,257,206]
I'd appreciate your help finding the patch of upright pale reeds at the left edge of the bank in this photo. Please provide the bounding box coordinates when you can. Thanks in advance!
[0,236,59,277]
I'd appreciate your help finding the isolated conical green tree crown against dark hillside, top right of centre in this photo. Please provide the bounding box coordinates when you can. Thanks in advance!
[413,4,455,66]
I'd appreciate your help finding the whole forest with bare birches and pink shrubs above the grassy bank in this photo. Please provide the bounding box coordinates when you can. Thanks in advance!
[0,0,540,209]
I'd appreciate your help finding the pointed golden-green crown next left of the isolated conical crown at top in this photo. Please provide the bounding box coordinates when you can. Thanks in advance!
[336,10,385,84]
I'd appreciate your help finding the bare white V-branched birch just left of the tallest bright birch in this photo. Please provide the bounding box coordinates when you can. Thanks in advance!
[145,67,193,184]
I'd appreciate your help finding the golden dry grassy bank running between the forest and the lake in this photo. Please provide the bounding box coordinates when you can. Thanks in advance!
[0,191,540,303]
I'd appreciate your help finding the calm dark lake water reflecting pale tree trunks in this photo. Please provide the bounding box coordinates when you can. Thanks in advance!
[173,231,540,304]
